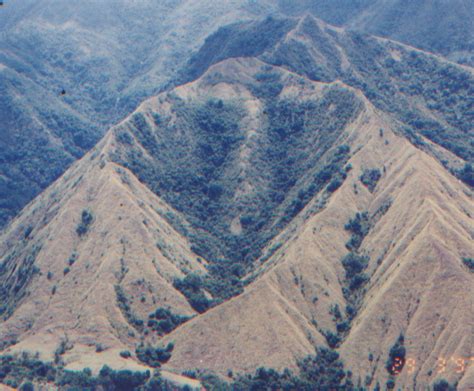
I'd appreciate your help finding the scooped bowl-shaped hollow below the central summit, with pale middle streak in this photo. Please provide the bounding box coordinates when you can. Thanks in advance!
[113,60,360,278]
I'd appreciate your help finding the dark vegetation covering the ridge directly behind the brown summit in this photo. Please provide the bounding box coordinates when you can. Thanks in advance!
[187,15,474,183]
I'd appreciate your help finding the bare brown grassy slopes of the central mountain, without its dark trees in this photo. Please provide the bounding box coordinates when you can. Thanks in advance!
[0,59,474,390]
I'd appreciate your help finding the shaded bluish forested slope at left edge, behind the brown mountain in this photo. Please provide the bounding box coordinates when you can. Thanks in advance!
[0,74,104,228]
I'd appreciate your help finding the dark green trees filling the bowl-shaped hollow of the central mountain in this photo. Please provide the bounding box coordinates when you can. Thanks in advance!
[114,81,360,304]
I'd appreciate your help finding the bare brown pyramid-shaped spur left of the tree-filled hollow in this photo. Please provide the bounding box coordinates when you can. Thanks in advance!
[0,132,208,374]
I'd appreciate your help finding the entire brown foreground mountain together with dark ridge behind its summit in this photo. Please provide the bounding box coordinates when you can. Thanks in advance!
[0,16,474,390]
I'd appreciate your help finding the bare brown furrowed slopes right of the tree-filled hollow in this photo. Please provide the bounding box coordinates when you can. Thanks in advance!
[157,72,474,389]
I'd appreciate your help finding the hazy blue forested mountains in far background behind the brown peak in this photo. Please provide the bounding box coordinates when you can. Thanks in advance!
[0,0,474,233]
